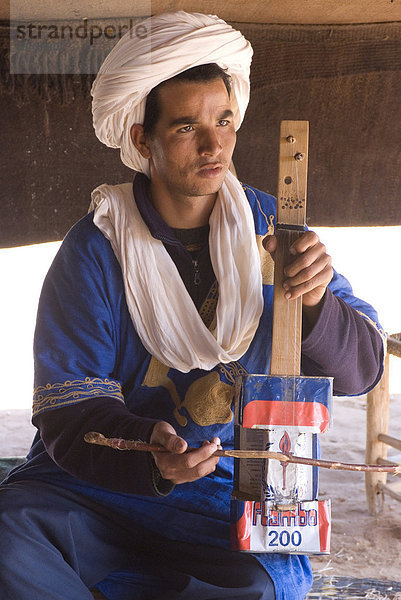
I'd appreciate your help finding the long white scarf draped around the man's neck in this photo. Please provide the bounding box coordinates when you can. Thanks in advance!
[90,171,263,373]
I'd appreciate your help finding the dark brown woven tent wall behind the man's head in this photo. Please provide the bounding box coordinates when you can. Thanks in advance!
[0,20,401,247]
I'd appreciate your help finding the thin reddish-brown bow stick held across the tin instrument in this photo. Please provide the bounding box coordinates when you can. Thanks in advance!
[84,431,401,475]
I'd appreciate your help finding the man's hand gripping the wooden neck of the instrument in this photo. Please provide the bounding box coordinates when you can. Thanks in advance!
[263,231,333,308]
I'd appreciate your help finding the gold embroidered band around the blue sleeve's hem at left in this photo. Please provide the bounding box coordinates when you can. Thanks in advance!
[33,377,124,416]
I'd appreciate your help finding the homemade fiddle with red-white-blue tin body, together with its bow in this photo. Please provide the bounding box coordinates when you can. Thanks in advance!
[85,121,401,554]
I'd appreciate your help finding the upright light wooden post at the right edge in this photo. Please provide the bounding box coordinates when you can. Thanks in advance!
[365,354,390,515]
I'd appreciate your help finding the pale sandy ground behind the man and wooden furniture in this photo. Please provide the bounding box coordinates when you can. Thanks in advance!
[0,395,401,582]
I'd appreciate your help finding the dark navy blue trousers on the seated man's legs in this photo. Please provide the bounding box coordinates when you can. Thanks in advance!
[0,481,275,600]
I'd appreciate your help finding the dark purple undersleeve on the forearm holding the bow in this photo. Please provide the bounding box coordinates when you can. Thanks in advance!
[33,398,174,496]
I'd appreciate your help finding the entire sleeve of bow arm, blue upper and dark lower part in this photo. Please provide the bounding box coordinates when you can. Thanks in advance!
[33,215,172,495]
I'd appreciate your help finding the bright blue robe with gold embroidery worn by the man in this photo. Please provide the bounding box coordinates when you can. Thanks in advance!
[8,186,377,600]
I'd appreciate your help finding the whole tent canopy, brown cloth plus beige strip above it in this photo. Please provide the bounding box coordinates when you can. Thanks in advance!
[0,0,401,247]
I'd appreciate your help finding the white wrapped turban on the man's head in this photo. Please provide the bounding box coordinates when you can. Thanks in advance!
[92,11,253,175]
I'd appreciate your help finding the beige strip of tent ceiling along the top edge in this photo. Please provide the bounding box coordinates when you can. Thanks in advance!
[4,0,401,24]
